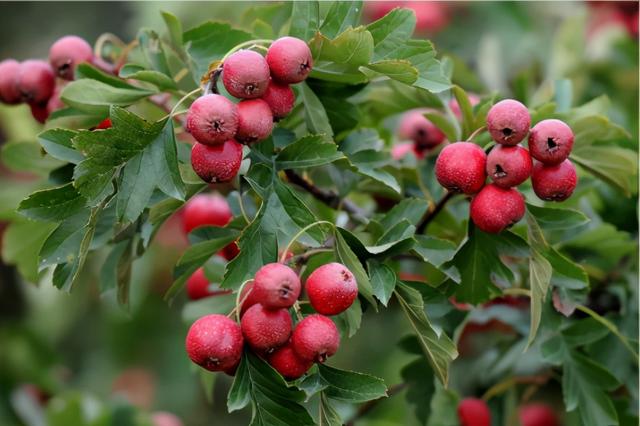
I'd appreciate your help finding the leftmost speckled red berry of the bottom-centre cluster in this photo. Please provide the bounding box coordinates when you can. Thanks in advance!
[186,314,243,371]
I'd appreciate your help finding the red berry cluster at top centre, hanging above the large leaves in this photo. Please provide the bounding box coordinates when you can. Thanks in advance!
[186,37,313,183]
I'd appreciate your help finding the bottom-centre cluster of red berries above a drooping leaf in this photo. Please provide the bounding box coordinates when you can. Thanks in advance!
[186,263,358,380]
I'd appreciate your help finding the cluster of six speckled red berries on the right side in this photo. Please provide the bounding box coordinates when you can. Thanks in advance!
[436,99,578,233]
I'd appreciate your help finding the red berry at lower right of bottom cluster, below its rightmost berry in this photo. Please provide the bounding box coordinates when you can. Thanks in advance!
[291,314,340,362]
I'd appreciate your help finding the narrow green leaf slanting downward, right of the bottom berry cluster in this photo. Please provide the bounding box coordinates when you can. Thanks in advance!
[394,283,458,386]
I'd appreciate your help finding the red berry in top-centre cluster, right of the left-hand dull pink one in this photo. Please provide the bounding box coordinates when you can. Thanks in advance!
[236,99,273,143]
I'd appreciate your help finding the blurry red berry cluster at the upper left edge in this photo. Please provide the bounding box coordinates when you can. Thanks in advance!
[0,36,99,123]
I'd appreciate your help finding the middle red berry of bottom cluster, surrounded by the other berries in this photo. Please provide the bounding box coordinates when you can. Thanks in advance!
[240,303,293,353]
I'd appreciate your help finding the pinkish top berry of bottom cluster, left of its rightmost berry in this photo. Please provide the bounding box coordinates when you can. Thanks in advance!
[253,263,300,309]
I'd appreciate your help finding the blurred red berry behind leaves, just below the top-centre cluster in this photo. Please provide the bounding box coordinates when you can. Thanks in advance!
[182,194,233,234]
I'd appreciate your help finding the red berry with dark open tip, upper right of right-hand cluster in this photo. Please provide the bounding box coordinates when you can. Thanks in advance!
[529,119,573,166]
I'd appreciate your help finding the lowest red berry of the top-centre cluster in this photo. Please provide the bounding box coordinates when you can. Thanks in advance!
[191,139,242,183]
